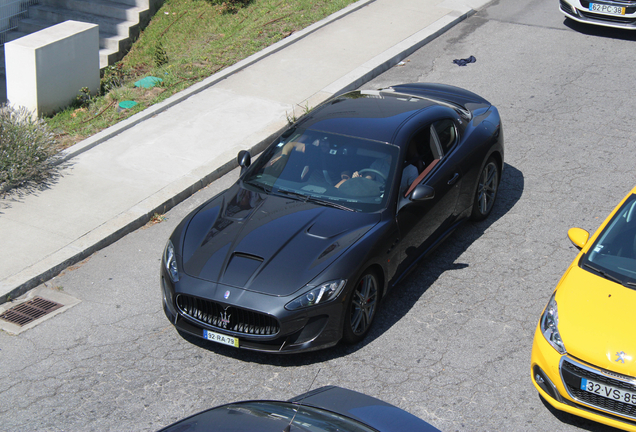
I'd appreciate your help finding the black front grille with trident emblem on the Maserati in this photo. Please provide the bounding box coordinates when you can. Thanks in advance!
[177,294,280,336]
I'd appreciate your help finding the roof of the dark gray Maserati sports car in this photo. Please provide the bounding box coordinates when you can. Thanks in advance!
[297,90,438,143]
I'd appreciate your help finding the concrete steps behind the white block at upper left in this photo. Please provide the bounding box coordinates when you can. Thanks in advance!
[0,0,163,69]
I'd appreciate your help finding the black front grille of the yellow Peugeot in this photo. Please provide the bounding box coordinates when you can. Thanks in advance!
[561,359,636,419]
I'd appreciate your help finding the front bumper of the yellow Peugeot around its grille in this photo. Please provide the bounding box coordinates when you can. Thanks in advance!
[530,326,636,432]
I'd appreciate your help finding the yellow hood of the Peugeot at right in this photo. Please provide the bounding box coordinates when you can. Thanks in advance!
[556,264,636,376]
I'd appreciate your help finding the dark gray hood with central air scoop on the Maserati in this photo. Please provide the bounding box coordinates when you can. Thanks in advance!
[182,185,380,296]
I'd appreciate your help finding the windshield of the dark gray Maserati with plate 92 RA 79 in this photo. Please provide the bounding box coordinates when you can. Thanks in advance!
[243,128,399,212]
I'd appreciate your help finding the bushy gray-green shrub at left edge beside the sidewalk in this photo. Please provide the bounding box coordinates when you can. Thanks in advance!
[0,104,57,191]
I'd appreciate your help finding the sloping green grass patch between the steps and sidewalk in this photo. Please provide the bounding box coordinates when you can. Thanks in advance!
[45,0,355,148]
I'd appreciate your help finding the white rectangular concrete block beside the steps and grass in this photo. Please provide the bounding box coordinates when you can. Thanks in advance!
[5,21,99,116]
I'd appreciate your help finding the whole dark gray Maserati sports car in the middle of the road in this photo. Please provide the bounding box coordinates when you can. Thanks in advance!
[161,84,504,352]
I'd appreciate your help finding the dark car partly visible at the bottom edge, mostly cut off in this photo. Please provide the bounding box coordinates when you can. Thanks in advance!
[160,386,439,432]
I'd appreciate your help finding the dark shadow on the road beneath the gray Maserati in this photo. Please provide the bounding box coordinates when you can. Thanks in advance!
[176,164,524,367]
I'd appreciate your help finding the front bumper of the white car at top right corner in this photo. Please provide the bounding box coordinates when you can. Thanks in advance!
[559,0,636,30]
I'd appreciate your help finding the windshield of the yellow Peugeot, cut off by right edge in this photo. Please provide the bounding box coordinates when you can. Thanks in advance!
[580,195,636,288]
